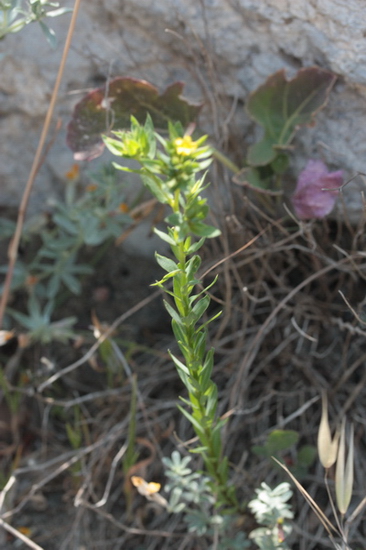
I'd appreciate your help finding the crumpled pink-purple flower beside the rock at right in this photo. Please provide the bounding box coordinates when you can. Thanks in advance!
[291,160,343,220]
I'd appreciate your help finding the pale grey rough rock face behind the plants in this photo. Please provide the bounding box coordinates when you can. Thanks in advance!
[0,0,366,223]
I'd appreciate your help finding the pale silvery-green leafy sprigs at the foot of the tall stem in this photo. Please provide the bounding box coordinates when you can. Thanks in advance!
[163,451,293,550]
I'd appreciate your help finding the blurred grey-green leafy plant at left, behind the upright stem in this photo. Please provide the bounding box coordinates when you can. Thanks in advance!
[0,166,131,345]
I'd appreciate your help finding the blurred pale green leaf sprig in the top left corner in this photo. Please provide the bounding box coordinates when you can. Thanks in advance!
[0,0,72,47]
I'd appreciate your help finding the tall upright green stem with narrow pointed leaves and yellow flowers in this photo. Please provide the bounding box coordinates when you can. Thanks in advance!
[104,116,238,510]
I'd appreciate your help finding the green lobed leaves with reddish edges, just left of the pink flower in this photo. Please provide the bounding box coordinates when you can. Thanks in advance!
[235,67,336,194]
